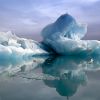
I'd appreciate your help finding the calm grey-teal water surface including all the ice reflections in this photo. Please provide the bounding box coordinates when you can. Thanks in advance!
[0,57,100,100]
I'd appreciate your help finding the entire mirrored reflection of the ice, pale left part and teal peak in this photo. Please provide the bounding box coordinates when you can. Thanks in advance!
[0,56,100,97]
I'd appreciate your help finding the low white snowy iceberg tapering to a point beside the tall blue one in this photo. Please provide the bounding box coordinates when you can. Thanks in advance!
[0,32,48,61]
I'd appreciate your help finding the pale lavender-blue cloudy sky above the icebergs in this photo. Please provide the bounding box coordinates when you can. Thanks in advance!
[0,0,100,40]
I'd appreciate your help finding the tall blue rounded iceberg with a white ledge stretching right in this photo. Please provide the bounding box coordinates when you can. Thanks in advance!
[42,14,100,55]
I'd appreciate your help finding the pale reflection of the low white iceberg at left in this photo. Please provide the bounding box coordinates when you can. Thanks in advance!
[0,56,47,77]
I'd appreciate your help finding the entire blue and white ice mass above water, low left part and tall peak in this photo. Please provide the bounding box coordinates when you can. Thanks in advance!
[0,14,100,58]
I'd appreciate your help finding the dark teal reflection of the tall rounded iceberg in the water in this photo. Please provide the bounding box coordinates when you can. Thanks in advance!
[42,56,100,97]
